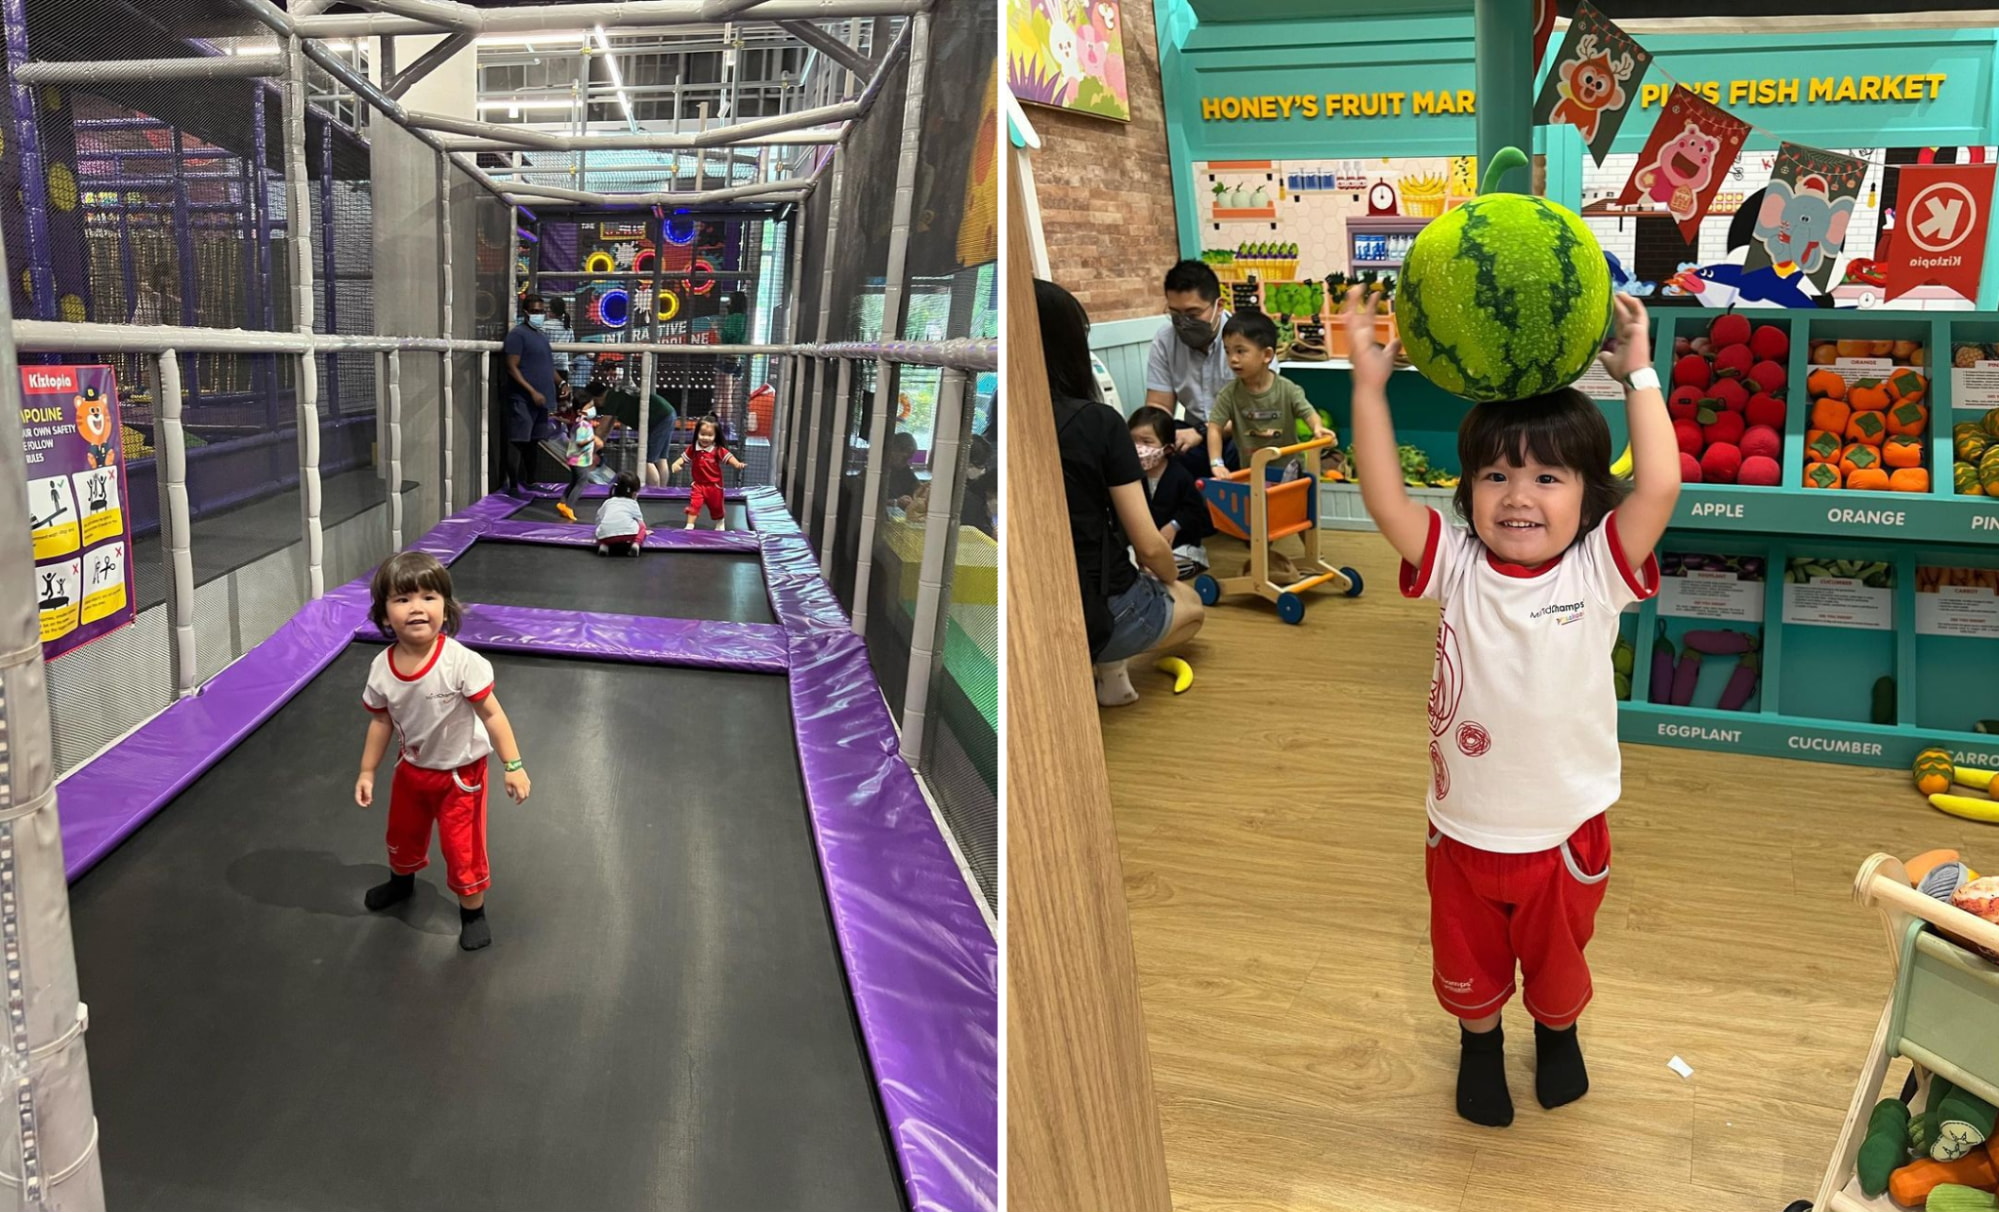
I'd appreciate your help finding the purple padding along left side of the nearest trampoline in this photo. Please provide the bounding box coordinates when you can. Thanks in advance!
[58,582,368,881]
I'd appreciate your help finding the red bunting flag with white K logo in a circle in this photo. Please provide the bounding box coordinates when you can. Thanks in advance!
[1881,164,1995,300]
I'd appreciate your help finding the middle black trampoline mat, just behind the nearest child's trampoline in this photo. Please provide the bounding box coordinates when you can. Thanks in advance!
[445,540,778,627]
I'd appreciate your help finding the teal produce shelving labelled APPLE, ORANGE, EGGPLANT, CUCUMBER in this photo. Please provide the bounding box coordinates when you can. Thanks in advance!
[1283,308,1999,769]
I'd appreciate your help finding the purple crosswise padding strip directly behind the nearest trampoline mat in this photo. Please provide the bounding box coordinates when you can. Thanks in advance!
[354,602,788,673]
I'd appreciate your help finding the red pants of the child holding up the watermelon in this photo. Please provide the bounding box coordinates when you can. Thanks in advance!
[1423,813,1611,1029]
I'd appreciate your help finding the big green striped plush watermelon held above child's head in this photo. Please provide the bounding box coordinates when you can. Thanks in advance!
[1395,148,1611,402]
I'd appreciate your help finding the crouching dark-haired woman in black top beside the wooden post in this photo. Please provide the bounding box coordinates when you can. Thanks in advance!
[1033,280,1201,707]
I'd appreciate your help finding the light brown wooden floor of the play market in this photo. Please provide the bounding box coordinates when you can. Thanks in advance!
[1101,534,1999,1209]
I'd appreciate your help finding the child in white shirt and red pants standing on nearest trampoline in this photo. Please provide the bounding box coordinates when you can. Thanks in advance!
[354,552,528,951]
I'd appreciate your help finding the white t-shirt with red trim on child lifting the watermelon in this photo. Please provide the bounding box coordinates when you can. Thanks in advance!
[1401,510,1659,853]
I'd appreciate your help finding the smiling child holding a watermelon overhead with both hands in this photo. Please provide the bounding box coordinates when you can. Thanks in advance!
[1347,292,1679,1127]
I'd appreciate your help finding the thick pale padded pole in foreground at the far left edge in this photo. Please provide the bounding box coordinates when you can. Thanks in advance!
[0,189,104,1209]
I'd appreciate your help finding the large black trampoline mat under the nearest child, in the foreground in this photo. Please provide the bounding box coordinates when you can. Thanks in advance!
[70,645,902,1209]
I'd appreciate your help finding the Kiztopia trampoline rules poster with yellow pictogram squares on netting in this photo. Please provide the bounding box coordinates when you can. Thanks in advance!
[20,366,138,661]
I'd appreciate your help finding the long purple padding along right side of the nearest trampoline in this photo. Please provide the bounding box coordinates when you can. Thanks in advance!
[792,631,1000,1209]
